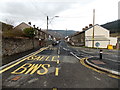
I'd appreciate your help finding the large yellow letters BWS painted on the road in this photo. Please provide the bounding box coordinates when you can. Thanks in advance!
[11,63,50,75]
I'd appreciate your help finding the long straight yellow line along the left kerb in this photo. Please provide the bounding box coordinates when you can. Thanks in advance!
[0,48,47,74]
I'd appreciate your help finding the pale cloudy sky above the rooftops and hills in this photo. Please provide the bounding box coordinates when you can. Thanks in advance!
[0,0,120,31]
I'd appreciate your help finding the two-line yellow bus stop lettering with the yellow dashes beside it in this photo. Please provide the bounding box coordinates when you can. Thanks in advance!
[11,55,60,76]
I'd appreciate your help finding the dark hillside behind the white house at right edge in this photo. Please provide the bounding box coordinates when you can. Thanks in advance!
[101,19,120,33]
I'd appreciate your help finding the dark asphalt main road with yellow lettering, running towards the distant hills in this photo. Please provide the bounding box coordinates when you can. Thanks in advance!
[0,41,119,90]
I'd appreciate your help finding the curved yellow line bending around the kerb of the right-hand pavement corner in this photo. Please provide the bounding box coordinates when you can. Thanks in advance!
[80,58,120,79]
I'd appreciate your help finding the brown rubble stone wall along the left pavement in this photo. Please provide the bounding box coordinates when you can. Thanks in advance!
[2,38,39,56]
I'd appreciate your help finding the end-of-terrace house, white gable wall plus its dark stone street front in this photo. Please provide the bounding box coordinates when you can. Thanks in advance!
[70,24,117,48]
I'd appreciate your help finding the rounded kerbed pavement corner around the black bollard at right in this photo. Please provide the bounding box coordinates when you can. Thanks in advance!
[85,57,120,76]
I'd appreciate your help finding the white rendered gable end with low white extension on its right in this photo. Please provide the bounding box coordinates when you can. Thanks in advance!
[85,24,117,48]
